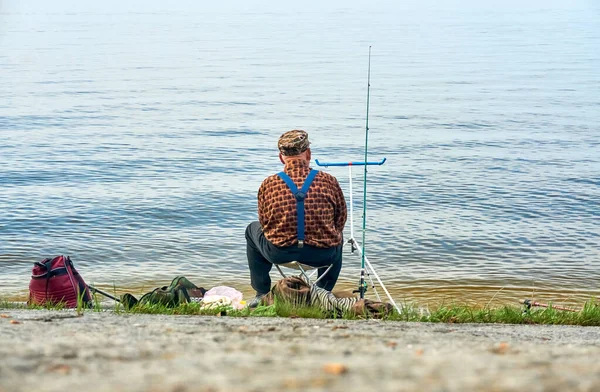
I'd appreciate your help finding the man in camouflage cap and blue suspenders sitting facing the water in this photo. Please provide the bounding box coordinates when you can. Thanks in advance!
[246,130,347,307]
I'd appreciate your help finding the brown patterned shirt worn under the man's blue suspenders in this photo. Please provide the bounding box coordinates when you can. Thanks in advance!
[258,159,347,248]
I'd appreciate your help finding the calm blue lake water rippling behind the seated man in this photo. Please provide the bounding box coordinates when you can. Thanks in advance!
[0,0,600,304]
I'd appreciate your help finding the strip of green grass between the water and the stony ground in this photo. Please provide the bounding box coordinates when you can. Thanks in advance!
[0,297,600,326]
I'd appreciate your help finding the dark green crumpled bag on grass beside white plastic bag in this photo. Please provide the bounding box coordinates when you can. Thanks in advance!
[121,276,206,309]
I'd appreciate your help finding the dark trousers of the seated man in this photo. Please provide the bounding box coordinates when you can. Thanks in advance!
[246,222,343,294]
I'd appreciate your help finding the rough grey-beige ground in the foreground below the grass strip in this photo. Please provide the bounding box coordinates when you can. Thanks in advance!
[0,310,600,392]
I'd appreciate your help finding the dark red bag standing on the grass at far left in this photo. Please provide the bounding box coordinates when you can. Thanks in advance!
[27,256,92,308]
